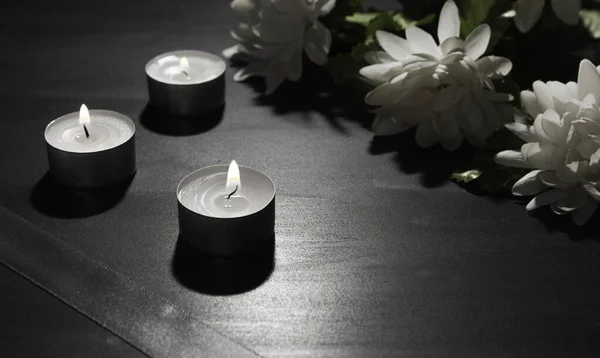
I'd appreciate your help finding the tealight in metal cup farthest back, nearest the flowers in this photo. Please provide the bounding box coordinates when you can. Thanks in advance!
[146,50,227,117]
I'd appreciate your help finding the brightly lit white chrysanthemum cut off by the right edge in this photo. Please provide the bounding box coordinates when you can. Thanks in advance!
[496,60,600,225]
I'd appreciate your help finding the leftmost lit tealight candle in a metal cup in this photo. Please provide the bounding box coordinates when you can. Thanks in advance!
[44,105,136,188]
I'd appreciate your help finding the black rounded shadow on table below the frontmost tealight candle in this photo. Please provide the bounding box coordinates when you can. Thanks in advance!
[171,236,275,296]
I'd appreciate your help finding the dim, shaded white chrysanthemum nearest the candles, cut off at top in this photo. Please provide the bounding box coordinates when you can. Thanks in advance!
[223,0,336,94]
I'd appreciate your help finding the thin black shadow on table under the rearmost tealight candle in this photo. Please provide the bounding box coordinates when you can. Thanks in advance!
[140,105,225,137]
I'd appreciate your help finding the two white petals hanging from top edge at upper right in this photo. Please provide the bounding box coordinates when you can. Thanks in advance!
[515,0,581,32]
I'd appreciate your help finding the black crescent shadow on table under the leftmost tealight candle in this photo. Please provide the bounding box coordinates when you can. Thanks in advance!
[29,173,135,219]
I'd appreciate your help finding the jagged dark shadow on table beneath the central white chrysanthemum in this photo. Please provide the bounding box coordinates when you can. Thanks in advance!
[369,130,473,188]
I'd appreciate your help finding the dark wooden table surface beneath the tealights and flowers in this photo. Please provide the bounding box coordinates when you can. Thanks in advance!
[0,0,600,357]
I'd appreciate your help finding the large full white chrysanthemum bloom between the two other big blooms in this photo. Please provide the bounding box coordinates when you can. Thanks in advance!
[360,1,512,150]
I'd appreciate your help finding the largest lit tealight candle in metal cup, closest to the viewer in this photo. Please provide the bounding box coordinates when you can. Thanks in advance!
[177,161,275,256]
